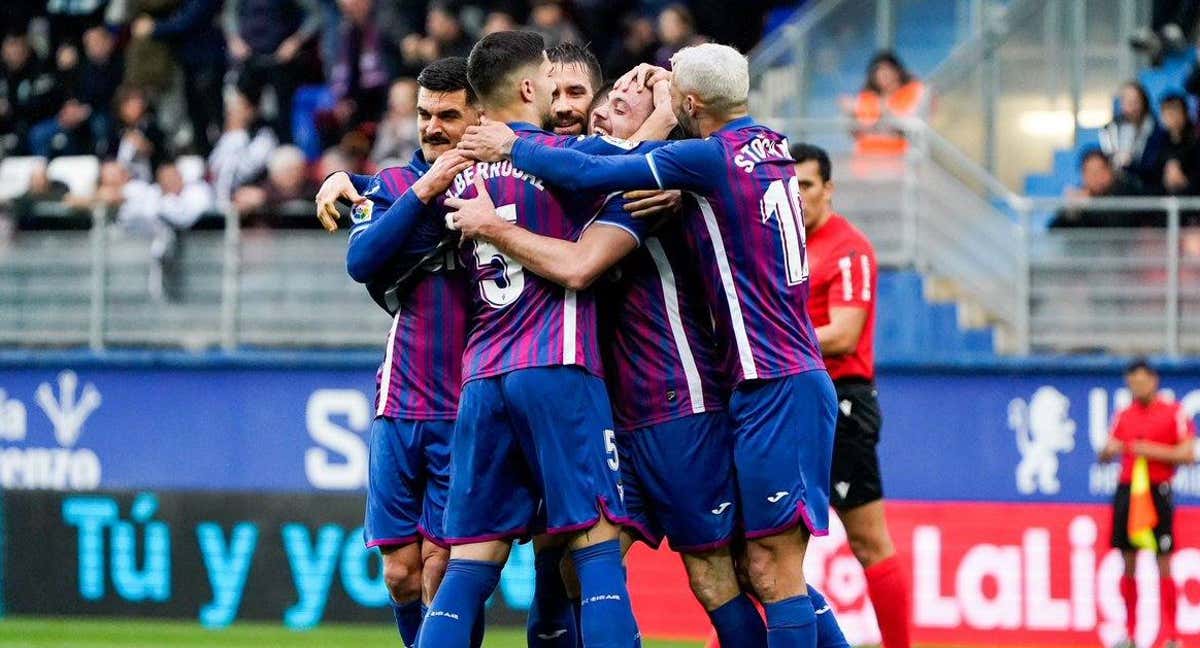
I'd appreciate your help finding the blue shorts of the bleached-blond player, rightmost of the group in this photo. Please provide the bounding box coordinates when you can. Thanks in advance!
[730,370,838,539]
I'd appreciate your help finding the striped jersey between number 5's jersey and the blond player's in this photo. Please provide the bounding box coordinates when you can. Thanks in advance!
[596,204,728,431]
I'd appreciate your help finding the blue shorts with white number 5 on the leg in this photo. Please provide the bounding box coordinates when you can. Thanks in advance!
[445,366,625,545]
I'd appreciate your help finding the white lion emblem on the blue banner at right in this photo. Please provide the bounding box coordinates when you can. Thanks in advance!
[1008,385,1075,494]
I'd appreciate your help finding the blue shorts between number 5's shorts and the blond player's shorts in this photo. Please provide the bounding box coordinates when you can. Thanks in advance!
[617,412,738,553]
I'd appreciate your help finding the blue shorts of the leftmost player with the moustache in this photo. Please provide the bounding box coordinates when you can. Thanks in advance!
[362,416,454,547]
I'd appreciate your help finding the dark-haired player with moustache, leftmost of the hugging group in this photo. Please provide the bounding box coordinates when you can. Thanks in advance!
[317,58,480,647]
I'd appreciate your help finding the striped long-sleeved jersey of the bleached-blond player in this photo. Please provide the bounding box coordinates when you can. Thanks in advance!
[512,116,824,382]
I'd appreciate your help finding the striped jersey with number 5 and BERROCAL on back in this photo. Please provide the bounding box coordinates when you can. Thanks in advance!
[446,124,605,383]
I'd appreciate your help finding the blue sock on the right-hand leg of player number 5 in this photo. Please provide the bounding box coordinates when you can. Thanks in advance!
[568,540,638,648]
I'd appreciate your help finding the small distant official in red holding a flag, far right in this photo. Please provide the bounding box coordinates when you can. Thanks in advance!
[1099,360,1195,648]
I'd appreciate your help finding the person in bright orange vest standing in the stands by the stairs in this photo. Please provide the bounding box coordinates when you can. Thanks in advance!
[840,50,929,156]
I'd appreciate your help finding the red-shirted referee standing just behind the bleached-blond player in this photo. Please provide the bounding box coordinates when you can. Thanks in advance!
[791,144,912,648]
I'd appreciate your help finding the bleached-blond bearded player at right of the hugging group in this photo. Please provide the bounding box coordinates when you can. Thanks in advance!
[460,44,835,647]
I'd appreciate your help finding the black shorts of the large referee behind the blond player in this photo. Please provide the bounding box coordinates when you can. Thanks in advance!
[829,378,883,511]
